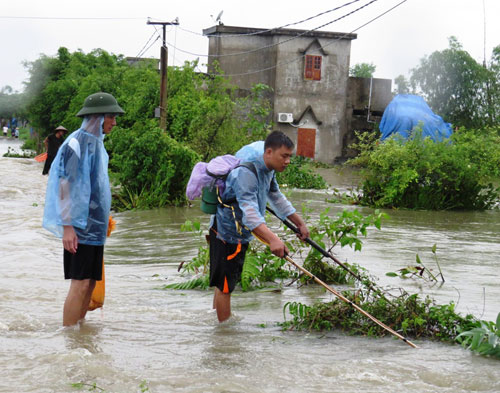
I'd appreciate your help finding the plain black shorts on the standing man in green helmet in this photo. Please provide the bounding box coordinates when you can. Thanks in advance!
[64,243,104,281]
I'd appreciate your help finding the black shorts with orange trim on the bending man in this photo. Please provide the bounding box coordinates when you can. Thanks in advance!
[210,225,248,293]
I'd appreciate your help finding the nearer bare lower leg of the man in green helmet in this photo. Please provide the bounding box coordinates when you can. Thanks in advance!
[63,279,95,326]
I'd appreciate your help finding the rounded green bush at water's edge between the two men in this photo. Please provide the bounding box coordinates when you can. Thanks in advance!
[107,127,199,209]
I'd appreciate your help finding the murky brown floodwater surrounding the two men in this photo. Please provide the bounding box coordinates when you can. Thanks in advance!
[0,138,500,393]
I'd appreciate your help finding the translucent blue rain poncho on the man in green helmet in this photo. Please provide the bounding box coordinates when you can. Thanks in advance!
[43,115,111,245]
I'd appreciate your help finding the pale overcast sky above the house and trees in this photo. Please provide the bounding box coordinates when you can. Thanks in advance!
[0,0,500,91]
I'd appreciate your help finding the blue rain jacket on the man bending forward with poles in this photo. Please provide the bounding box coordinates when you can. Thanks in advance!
[216,154,295,244]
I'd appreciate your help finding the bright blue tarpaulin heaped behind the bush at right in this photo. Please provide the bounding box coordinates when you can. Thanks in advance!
[380,94,452,141]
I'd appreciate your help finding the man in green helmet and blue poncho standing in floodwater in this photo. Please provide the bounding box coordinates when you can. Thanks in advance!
[43,93,124,326]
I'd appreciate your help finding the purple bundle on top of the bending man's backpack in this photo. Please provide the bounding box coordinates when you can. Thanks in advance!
[186,154,240,200]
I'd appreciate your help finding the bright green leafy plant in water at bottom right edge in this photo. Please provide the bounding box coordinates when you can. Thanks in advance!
[456,313,500,359]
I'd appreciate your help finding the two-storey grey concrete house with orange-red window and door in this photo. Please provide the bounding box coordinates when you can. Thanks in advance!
[203,24,390,163]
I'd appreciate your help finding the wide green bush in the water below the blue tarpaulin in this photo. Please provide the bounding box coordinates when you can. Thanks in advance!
[352,128,500,210]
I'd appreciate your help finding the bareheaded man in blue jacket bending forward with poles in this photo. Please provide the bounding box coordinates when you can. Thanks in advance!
[210,131,309,322]
